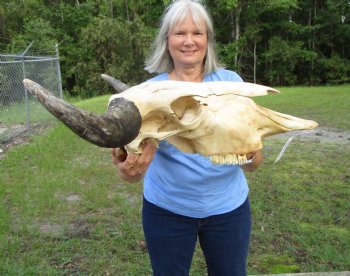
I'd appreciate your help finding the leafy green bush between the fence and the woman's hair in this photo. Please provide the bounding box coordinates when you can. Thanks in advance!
[75,17,152,96]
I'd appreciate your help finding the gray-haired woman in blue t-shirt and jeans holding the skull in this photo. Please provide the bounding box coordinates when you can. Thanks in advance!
[112,0,262,276]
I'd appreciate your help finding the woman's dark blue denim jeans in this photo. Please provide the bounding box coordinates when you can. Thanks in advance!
[142,199,251,276]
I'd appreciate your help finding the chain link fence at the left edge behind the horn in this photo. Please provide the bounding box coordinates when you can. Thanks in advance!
[0,42,63,145]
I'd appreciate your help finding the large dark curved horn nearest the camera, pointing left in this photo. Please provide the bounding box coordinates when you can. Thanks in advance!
[23,79,141,148]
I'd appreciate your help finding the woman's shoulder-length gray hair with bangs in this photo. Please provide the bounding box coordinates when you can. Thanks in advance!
[145,0,221,74]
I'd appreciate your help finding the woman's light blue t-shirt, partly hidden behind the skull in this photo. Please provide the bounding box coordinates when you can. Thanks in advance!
[144,69,249,218]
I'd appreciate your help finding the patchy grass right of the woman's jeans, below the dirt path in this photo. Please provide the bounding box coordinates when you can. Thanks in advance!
[248,140,350,273]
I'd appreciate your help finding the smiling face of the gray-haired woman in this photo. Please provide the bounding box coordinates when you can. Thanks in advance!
[168,16,208,69]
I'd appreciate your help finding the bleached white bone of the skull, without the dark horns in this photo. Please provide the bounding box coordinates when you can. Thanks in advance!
[110,81,317,164]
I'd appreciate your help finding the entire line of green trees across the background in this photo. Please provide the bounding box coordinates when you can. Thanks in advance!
[0,0,350,97]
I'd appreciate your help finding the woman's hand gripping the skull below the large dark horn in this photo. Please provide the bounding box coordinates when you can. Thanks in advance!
[112,143,157,183]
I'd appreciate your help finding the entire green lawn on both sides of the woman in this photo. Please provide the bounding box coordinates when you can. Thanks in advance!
[0,86,350,276]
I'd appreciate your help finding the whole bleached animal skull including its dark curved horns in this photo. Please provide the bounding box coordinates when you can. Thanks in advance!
[23,75,318,164]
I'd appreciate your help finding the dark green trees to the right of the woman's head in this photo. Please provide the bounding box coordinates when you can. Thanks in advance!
[206,0,350,85]
